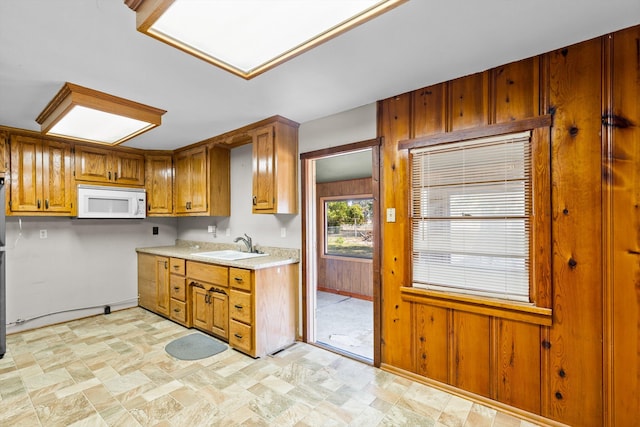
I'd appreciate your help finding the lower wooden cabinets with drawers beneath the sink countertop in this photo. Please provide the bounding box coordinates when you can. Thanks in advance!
[138,253,298,357]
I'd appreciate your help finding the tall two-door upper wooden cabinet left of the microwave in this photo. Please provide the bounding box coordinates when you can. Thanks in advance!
[8,135,75,216]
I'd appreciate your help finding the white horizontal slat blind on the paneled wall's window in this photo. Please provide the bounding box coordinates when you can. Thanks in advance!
[411,131,531,302]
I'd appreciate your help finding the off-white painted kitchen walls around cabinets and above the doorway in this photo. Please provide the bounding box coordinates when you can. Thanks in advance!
[6,104,376,333]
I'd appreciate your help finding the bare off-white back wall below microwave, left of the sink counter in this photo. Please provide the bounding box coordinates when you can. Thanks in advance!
[6,217,177,333]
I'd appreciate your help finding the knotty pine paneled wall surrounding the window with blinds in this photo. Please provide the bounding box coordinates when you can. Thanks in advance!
[378,26,640,426]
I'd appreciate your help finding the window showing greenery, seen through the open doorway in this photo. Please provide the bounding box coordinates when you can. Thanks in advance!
[322,197,373,259]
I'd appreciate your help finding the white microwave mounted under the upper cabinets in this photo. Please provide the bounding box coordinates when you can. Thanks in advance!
[78,184,147,218]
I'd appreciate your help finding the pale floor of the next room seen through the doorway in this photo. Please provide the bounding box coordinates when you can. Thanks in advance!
[316,291,373,361]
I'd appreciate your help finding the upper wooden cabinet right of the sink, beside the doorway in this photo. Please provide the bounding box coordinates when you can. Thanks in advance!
[252,119,298,214]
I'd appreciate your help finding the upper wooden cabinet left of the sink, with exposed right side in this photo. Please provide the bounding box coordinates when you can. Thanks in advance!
[174,145,231,216]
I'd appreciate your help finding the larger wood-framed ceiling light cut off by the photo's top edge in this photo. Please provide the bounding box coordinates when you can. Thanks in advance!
[125,0,408,80]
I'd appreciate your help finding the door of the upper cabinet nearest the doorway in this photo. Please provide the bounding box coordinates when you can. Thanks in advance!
[253,126,275,211]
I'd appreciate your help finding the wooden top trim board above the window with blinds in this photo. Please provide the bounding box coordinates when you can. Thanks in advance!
[398,114,553,150]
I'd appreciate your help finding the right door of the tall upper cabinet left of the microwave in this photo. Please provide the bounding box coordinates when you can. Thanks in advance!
[42,141,74,214]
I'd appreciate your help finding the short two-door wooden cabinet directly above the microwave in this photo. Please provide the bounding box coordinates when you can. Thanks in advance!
[75,145,145,186]
